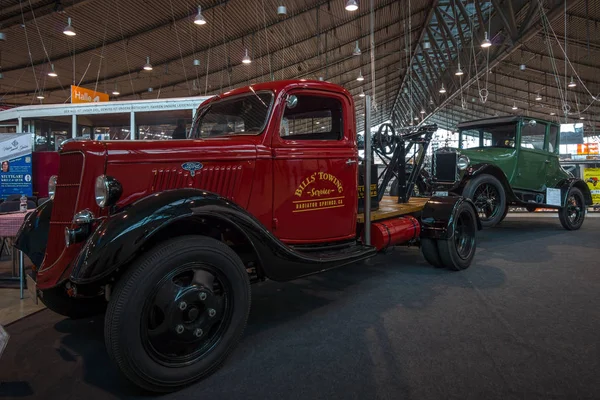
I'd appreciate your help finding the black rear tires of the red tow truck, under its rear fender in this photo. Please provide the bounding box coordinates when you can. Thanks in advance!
[437,203,477,271]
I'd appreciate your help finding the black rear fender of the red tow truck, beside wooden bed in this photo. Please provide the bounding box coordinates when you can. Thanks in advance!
[421,196,482,239]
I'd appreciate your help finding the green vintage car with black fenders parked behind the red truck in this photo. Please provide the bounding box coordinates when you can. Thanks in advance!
[431,116,592,230]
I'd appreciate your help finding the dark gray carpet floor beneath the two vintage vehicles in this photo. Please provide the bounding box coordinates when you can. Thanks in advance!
[0,218,600,400]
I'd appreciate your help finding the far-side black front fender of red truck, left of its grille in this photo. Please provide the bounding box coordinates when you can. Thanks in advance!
[15,200,54,268]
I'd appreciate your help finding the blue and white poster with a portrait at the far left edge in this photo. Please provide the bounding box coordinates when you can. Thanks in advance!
[0,133,33,198]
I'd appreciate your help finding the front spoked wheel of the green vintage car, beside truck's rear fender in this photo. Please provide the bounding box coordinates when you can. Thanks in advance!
[462,174,507,228]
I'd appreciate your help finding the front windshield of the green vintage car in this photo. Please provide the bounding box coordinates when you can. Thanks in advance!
[459,123,517,149]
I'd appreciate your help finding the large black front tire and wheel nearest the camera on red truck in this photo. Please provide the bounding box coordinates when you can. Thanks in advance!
[104,236,250,392]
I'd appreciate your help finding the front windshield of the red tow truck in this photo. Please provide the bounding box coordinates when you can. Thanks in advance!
[190,92,273,138]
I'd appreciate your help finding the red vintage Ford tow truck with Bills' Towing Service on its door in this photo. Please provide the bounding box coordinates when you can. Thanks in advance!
[16,80,481,392]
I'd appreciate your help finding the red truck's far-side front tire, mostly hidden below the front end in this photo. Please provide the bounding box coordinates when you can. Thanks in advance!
[39,286,107,319]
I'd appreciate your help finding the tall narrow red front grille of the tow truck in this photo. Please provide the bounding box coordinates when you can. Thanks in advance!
[43,153,84,269]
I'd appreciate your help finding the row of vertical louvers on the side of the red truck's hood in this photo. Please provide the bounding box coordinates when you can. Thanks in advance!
[151,164,242,201]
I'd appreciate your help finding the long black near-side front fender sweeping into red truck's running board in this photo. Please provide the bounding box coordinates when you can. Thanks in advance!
[71,189,375,284]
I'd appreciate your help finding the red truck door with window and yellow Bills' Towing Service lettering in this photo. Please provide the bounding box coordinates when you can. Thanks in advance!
[272,89,358,244]
